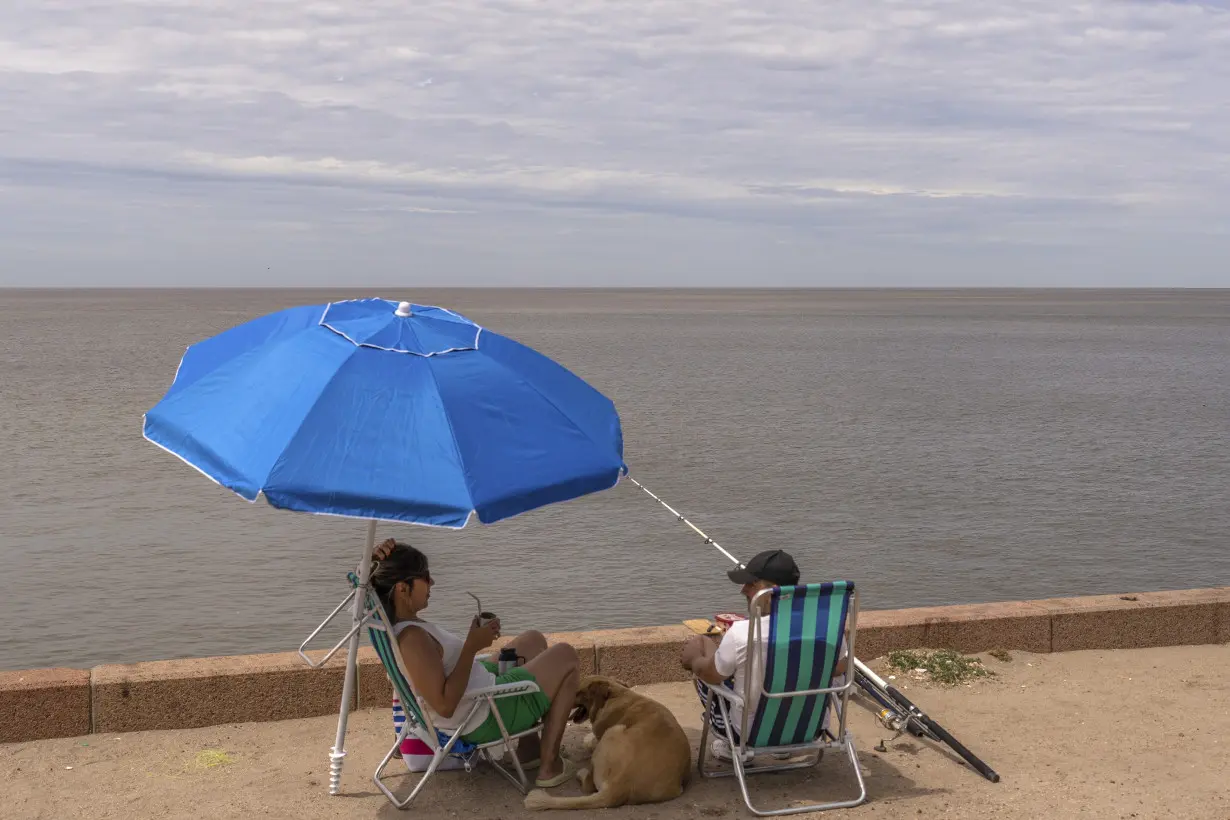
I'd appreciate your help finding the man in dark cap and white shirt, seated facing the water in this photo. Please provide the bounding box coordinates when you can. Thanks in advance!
[679,550,845,760]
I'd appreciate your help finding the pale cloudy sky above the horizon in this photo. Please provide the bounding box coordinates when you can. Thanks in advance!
[0,0,1230,286]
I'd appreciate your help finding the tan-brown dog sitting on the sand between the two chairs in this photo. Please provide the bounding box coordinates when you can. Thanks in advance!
[525,675,691,809]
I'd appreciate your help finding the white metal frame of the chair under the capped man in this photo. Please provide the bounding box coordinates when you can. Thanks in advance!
[696,588,867,818]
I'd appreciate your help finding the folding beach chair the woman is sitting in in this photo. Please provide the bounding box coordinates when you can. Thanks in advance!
[349,573,541,809]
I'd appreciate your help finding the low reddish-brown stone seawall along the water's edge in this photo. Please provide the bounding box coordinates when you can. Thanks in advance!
[0,586,1230,743]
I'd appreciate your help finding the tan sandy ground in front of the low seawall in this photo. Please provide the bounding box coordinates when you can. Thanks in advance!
[0,645,1230,820]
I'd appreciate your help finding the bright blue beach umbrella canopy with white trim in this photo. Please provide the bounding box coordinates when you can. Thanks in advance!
[144,299,625,529]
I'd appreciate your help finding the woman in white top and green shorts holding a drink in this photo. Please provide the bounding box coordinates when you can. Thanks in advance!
[371,538,581,788]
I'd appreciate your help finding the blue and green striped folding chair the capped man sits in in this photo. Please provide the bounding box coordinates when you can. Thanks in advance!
[696,580,867,816]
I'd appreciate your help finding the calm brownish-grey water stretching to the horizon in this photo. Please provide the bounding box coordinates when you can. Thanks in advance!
[0,288,1230,669]
